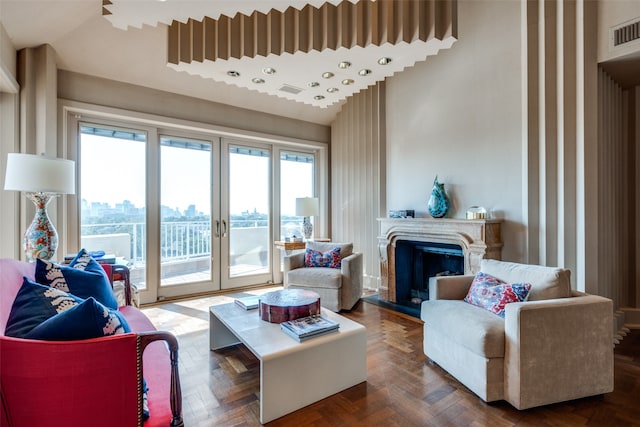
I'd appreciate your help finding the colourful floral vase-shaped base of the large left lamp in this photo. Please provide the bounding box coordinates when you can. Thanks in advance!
[22,193,58,262]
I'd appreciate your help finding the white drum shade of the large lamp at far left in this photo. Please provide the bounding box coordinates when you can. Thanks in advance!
[4,153,76,194]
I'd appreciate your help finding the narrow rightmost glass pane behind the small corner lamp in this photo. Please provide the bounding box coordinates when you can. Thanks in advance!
[280,151,315,240]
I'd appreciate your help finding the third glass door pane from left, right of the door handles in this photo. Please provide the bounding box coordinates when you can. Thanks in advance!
[222,145,272,288]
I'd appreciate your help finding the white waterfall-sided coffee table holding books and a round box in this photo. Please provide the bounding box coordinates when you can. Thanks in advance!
[209,303,367,424]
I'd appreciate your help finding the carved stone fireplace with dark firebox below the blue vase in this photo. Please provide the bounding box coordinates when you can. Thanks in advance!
[378,218,502,303]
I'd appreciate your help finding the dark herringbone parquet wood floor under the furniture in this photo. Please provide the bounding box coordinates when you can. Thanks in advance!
[144,291,640,427]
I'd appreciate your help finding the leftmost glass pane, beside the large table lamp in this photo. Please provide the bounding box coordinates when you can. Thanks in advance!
[79,123,147,290]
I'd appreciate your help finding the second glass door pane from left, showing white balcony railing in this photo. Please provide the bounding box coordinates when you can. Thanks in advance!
[160,136,213,296]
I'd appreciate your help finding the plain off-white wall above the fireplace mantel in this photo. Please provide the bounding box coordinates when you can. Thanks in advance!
[386,1,525,260]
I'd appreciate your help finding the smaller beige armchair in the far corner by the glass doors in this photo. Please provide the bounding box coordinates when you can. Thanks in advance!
[284,242,362,312]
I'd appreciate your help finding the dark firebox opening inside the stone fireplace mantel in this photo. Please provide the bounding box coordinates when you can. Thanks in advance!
[395,240,464,308]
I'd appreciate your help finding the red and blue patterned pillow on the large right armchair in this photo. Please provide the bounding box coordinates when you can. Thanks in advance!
[464,272,531,318]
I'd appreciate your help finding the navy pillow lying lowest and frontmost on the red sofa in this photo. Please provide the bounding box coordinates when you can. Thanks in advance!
[25,297,131,341]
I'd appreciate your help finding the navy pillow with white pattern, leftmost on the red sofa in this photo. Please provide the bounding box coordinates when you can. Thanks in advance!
[5,277,83,338]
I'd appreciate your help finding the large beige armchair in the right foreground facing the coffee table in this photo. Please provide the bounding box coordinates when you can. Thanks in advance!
[421,260,613,409]
